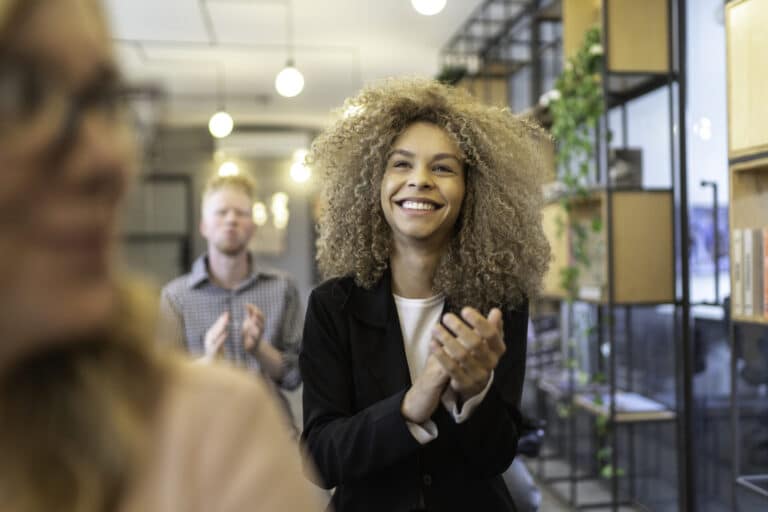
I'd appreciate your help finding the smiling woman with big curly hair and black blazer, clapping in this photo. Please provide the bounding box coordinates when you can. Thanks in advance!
[299,80,549,512]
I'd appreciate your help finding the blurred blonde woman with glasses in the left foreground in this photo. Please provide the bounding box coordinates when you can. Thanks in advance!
[0,0,318,512]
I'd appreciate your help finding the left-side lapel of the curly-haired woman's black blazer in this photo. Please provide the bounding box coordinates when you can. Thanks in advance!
[350,272,411,396]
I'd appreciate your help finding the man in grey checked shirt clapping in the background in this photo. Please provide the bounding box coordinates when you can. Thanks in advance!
[161,174,303,428]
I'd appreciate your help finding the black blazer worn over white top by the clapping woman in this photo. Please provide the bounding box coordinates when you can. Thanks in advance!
[299,274,528,512]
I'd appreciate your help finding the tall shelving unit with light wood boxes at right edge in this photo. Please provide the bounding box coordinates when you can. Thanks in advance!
[725,0,768,510]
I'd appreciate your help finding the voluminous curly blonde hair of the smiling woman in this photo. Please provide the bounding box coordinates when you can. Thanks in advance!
[307,79,550,310]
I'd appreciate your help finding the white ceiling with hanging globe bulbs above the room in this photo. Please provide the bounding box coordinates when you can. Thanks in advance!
[105,0,482,127]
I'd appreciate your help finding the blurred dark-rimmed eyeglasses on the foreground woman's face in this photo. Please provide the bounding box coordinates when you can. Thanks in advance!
[0,56,159,158]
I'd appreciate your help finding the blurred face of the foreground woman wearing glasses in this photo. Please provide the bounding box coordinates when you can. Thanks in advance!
[0,0,134,358]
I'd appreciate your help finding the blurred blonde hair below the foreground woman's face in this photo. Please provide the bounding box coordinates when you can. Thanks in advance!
[0,284,171,512]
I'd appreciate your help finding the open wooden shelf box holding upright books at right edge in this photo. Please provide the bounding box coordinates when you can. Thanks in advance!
[730,158,768,324]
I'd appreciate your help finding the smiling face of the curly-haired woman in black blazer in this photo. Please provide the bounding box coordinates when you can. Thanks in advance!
[381,122,465,254]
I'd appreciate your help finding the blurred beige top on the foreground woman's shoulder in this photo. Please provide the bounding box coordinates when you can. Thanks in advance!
[120,364,324,512]
